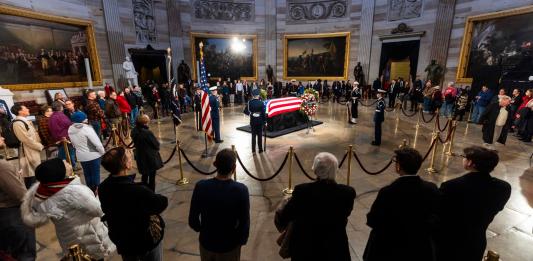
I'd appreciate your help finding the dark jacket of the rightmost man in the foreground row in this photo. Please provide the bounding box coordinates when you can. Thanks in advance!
[438,172,511,261]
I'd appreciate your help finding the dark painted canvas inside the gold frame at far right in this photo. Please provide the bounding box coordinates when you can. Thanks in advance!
[465,13,533,79]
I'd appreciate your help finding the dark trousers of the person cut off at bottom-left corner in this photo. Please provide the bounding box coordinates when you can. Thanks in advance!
[0,206,36,261]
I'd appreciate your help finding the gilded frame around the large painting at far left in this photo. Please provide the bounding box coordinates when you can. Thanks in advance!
[0,5,102,91]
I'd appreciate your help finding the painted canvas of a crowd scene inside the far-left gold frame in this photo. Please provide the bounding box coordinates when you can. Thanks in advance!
[0,14,89,85]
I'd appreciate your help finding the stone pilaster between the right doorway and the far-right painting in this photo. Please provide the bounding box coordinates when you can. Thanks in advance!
[430,0,456,67]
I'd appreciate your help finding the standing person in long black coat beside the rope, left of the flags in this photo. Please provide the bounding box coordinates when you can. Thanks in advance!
[131,114,163,191]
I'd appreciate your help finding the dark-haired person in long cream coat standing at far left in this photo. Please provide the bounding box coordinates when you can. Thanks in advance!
[11,104,44,188]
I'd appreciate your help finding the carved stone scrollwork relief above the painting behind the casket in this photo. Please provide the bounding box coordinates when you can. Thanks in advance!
[287,0,348,21]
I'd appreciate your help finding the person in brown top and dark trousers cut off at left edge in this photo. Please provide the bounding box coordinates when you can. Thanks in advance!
[0,137,36,261]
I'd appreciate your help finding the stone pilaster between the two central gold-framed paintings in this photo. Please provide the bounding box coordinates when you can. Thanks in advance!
[265,0,277,79]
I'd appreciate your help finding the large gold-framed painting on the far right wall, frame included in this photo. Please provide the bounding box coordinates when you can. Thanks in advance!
[456,6,533,83]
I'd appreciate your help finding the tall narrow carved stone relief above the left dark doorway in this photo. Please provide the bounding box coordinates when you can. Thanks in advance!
[132,0,157,43]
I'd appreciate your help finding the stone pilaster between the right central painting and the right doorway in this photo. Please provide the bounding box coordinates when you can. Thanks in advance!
[358,0,375,81]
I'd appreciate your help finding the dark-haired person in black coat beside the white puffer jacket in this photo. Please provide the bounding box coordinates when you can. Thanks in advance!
[99,147,168,261]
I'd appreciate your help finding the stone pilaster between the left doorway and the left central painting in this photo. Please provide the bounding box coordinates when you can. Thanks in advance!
[167,0,184,80]
